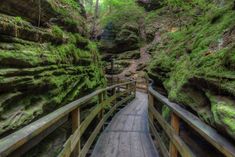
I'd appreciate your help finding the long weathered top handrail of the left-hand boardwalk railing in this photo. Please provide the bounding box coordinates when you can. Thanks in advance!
[0,81,134,157]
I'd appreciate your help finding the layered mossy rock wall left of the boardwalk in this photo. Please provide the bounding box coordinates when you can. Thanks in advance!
[0,0,105,137]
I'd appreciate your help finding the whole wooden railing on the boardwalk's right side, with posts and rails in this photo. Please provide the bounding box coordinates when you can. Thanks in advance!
[148,86,235,157]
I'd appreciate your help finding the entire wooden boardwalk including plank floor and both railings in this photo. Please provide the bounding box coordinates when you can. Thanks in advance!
[0,80,235,157]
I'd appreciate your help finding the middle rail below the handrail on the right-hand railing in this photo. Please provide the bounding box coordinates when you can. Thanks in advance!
[149,106,195,157]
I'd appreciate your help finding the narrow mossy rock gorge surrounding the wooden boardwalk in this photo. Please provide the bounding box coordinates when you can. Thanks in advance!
[0,0,235,157]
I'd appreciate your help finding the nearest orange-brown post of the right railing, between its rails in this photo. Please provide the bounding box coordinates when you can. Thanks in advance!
[169,112,180,157]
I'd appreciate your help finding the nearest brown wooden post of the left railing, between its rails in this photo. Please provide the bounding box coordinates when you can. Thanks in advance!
[71,108,81,157]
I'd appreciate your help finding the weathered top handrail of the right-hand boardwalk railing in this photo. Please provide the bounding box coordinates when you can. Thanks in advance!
[148,87,235,157]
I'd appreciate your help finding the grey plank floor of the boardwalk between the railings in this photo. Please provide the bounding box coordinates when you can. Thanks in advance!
[91,92,159,157]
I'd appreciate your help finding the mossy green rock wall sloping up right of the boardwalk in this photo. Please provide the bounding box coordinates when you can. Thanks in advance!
[148,1,235,140]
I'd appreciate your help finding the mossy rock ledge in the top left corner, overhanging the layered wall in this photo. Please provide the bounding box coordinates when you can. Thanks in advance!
[0,0,87,35]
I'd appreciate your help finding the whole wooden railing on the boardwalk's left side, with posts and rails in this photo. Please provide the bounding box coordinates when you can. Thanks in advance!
[0,81,135,157]
